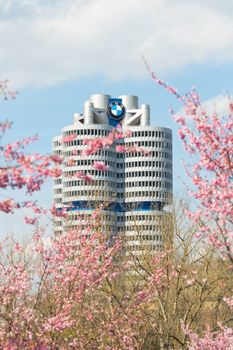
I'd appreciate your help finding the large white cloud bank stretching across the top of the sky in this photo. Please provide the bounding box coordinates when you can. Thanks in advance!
[0,0,233,87]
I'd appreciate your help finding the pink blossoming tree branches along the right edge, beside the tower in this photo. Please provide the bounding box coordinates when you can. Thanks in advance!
[143,57,233,350]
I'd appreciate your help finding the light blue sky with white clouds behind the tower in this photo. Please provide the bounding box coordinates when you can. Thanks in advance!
[0,0,233,235]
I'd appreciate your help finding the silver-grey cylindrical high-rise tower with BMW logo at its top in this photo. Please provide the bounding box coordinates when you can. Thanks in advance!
[53,94,172,252]
